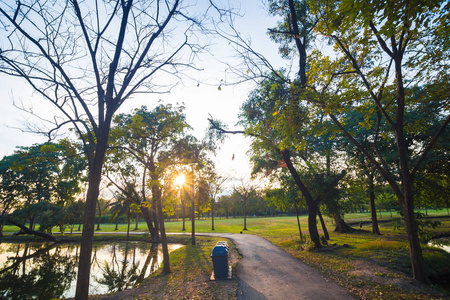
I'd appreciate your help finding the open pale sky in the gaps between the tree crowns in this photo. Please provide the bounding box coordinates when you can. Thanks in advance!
[0,0,280,183]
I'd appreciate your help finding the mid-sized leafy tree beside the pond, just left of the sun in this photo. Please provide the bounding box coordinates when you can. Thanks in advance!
[106,105,189,241]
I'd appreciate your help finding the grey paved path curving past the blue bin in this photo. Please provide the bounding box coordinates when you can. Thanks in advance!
[197,233,355,300]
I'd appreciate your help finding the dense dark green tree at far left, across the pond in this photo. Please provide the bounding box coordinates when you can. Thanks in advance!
[0,140,86,239]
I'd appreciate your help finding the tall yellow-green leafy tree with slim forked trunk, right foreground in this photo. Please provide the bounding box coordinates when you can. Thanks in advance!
[311,0,450,282]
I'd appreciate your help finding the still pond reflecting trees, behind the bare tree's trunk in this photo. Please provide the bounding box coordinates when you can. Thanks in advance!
[0,242,182,299]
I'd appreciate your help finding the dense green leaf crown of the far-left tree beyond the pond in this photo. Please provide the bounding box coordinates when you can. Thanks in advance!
[0,140,86,205]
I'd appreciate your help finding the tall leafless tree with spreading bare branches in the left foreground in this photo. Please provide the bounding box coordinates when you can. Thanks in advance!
[0,0,224,299]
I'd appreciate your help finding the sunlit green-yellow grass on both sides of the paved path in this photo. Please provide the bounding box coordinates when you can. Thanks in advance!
[4,210,450,299]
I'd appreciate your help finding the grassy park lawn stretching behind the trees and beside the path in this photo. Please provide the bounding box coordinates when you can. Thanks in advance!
[4,210,450,299]
